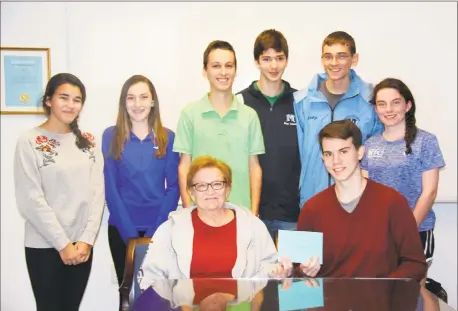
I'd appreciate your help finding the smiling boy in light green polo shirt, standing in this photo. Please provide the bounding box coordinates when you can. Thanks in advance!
[173,41,265,215]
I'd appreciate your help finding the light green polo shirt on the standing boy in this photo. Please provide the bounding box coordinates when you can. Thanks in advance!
[173,93,265,208]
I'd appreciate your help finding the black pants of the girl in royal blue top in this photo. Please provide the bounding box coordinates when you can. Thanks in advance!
[108,225,145,306]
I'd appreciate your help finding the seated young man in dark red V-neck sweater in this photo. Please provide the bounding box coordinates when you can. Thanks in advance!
[297,120,426,281]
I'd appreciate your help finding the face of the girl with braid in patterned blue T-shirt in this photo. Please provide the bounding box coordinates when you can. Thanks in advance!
[375,88,412,127]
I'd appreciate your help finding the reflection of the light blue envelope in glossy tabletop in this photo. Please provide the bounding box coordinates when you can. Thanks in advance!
[278,279,324,311]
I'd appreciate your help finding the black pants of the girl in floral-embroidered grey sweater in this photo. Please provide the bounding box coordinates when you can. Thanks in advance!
[25,247,94,311]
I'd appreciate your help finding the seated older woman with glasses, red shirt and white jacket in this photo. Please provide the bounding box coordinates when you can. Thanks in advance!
[138,156,292,290]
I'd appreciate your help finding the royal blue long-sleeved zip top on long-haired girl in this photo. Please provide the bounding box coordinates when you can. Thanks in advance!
[102,126,180,243]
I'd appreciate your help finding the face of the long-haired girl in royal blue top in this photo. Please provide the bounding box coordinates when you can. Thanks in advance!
[126,82,154,122]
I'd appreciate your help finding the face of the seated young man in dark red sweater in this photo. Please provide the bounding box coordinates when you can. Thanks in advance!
[321,137,364,182]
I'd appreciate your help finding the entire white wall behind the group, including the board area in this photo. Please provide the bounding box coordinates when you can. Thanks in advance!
[1,2,457,311]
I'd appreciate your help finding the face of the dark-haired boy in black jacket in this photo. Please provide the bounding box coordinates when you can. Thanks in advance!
[256,48,288,82]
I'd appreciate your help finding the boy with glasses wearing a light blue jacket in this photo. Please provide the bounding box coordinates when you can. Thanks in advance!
[294,31,383,206]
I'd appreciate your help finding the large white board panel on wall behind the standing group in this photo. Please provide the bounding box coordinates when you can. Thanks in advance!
[62,2,458,201]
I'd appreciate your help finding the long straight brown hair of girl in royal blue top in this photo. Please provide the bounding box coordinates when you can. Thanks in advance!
[110,75,168,161]
